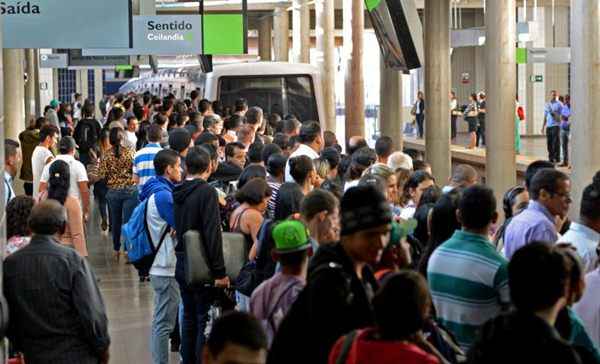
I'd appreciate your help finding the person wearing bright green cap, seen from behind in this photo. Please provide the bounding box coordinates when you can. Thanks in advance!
[250,220,312,346]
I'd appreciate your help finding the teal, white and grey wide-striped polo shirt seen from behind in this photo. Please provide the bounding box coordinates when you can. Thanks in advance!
[427,231,510,350]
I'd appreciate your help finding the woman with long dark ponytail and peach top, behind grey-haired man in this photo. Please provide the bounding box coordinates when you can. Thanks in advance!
[42,160,88,257]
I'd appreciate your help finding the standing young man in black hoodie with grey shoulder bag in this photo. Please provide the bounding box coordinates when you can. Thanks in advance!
[173,147,229,364]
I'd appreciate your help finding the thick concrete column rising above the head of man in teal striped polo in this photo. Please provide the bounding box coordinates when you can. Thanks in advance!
[485,0,517,205]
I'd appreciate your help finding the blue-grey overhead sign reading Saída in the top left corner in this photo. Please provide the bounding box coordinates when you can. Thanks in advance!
[0,0,132,49]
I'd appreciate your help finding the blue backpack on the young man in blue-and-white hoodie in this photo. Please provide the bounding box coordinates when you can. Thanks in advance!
[121,199,171,272]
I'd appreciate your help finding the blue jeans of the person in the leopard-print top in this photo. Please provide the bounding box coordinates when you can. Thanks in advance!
[106,186,138,251]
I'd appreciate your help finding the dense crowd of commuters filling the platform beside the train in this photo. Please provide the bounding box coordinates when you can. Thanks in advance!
[3,91,600,364]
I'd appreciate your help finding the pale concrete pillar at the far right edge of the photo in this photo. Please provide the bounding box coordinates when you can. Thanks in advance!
[571,0,600,218]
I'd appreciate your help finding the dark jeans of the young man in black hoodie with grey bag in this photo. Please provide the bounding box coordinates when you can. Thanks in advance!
[175,253,213,364]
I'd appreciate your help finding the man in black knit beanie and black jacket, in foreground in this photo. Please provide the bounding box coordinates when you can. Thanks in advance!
[267,186,392,364]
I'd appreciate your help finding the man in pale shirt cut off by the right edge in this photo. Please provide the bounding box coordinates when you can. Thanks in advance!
[558,178,600,273]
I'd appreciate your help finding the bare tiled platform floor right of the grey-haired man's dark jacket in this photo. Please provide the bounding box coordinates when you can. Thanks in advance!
[87,210,178,364]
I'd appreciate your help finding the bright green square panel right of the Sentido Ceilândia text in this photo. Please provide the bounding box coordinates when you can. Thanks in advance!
[203,14,245,55]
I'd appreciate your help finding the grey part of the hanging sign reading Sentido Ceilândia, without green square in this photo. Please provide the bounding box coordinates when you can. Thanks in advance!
[82,15,202,56]
